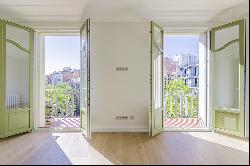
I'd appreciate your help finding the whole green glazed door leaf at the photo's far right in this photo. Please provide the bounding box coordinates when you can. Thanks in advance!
[211,20,245,137]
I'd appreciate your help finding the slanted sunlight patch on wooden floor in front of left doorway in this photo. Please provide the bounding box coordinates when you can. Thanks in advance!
[52,132,113,165]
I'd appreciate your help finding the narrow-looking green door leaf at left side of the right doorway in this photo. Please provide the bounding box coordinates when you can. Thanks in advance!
[149,22,164,136]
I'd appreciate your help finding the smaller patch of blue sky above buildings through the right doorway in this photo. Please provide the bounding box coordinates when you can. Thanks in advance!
[164,35,199,56]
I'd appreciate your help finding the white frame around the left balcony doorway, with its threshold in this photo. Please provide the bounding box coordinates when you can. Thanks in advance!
[33,29,80,132]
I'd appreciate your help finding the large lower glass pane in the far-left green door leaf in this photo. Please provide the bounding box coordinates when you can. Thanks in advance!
[6,42,30,109]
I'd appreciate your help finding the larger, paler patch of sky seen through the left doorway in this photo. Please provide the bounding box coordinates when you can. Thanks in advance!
[45,36,80,75]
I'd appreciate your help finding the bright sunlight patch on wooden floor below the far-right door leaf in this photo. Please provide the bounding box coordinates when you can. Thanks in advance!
[183,132,249,153]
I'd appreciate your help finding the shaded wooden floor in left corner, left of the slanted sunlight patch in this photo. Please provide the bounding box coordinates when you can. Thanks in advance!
[0,132,72,165]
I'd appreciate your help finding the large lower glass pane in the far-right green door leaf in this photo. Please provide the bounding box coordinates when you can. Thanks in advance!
[214,42,239,109]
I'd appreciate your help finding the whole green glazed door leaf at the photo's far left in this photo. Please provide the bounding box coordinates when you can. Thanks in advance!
[0,20,34,138]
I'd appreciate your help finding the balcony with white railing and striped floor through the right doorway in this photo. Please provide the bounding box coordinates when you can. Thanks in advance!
[164,91,205,129]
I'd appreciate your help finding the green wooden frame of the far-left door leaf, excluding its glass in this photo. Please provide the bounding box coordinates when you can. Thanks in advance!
[0,20,34,138]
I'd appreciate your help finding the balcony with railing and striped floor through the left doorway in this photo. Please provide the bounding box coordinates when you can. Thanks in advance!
[45,89,80,128]
